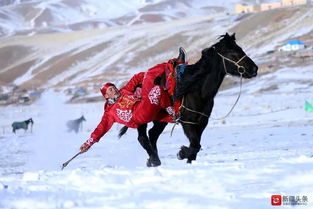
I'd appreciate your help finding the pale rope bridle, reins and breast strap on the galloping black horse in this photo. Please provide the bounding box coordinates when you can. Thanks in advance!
[175,52,247,124]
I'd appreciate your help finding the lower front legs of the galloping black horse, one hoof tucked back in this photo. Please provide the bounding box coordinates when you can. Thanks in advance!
[177,124,206,163]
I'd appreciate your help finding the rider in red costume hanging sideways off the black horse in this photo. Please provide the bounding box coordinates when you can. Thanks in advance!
[80,50,185,152]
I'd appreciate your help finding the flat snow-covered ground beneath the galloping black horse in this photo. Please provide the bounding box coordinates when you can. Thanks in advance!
[0,66,313,209]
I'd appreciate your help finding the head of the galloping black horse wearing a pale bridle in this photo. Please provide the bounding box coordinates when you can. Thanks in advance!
[208,33,258,78]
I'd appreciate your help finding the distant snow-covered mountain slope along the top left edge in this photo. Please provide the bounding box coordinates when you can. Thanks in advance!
[0,0,269,35]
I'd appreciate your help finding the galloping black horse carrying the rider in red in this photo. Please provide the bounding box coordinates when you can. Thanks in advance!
[119,33,258,167]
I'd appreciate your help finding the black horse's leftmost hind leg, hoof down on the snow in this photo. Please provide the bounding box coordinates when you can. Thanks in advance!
[137,124,161,167]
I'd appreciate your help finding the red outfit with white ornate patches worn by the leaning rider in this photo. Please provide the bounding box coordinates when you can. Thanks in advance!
[91,63,170,141]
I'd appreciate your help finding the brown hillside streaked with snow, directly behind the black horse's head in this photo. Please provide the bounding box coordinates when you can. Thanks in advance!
[0,2,313,99]
